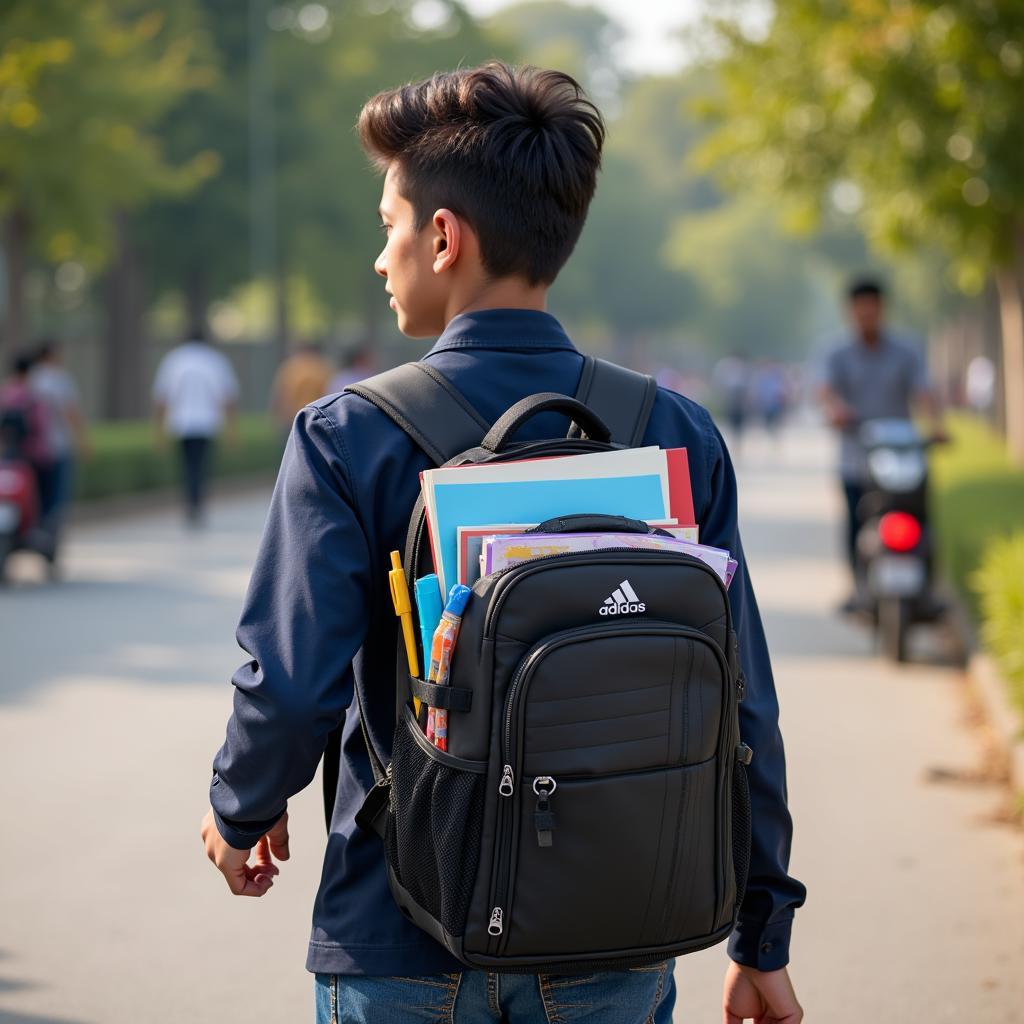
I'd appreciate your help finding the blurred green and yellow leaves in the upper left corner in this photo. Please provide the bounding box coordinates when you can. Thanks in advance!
[0,0,215,263]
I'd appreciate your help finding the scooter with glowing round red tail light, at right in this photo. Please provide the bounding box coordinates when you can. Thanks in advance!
[857,420,941,662]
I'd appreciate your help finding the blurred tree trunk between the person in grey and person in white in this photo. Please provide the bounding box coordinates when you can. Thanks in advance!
[103,210,148,420]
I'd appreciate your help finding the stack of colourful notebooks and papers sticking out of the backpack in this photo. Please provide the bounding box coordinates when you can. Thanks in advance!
[421,447,736,594]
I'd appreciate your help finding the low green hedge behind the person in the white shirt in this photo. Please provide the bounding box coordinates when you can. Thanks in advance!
[75,416,284,501]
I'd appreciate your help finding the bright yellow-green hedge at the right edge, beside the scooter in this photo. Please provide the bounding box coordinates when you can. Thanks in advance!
[932,416,1024,709]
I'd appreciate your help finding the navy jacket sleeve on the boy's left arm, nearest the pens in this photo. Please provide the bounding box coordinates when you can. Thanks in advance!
[210,407,371,850]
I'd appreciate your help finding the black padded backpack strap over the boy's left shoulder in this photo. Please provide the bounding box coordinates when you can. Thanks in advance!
[345,362,490,466]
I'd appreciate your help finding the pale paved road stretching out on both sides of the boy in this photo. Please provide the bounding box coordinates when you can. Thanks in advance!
[0,432,1024,1024]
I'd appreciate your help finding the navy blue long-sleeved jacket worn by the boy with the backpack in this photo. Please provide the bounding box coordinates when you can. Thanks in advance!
[210,309,804,975]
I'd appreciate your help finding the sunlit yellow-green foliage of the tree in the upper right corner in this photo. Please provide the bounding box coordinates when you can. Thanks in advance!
[703,0,1024,291]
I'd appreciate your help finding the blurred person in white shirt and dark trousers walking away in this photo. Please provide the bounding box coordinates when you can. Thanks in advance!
[153,326,239,525]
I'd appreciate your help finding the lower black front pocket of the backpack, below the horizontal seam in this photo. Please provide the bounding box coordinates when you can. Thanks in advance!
[502,761,717,956]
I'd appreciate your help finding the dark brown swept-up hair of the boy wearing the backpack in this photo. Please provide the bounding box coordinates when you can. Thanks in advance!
[358,60,604,285]
